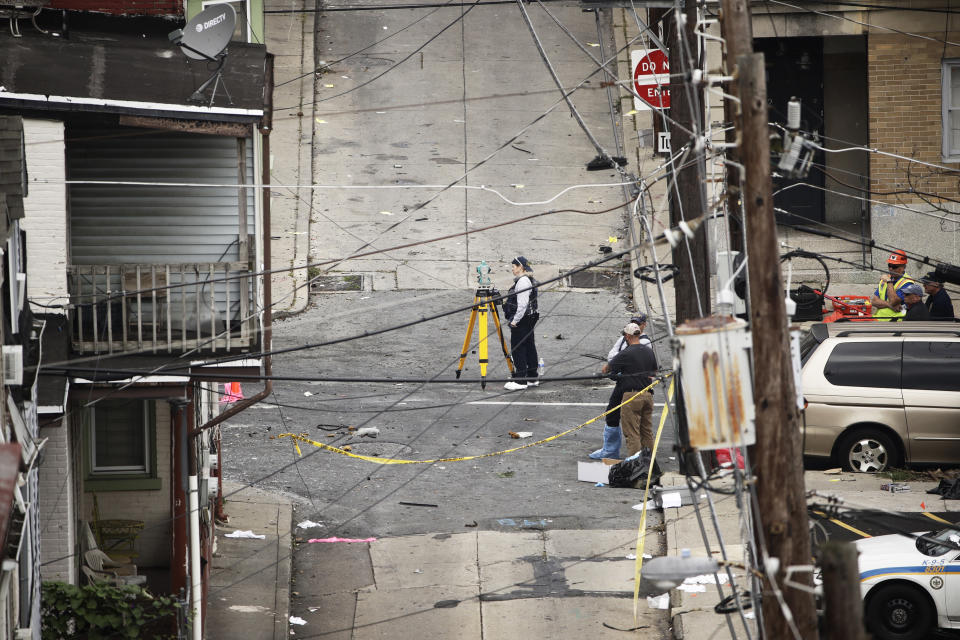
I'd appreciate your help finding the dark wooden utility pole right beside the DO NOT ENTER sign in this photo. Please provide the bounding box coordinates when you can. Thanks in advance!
[654,2,710,325]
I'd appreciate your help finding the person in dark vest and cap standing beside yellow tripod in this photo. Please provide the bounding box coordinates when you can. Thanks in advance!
[503,256,540,391]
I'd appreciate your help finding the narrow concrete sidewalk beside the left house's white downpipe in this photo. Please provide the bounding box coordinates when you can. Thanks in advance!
[210,482,293,640]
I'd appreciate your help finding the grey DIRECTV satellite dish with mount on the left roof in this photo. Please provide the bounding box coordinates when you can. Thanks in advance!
[168,3,237,107]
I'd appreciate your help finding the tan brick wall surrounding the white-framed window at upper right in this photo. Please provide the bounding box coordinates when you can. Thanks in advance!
[867,31,960,204]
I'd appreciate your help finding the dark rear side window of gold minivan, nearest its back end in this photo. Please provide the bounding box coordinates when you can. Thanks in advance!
[823,340,903,389]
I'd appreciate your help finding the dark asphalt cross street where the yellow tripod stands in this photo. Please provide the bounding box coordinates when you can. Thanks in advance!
[223,291,676,537]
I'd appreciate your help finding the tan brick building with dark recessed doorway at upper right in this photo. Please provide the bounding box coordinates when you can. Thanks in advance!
[707,0,960,278]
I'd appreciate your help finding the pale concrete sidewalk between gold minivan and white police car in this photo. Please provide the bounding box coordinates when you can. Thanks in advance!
[662,471,960,640]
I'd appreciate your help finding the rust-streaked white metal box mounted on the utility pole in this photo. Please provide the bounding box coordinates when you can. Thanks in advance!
[673,316,756,450]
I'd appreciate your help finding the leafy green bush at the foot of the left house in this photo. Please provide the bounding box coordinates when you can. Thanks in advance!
[41,582,182,640]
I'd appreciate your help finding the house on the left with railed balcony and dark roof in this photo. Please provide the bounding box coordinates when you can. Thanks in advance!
[0,0,272,637]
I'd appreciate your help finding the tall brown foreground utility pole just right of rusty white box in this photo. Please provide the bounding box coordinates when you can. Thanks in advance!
[725,51,817,640]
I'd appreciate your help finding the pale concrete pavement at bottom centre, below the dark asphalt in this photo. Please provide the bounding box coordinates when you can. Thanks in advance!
[292,524,669,640]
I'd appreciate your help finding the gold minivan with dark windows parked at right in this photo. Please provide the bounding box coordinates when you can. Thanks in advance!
[800,321,960,472]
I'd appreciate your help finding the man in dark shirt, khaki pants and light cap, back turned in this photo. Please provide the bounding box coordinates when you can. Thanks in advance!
[602,322,657,457]
